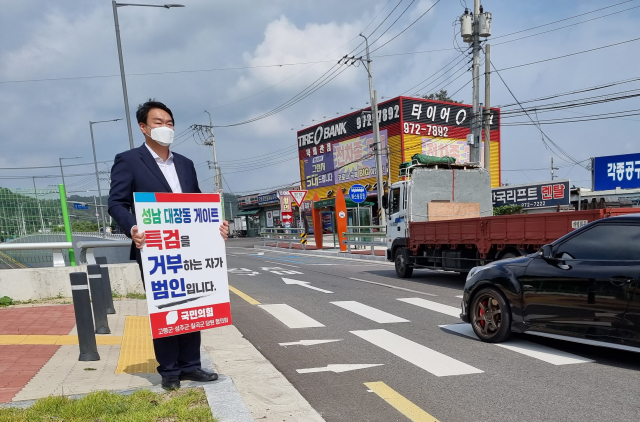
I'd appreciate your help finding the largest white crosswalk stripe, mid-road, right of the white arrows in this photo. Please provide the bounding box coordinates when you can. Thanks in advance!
[351,330,484,377]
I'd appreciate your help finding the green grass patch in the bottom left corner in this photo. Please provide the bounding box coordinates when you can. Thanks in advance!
[0,388,217,422]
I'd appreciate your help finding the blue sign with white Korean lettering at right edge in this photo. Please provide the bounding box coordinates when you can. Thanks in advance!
[593,153,640,190]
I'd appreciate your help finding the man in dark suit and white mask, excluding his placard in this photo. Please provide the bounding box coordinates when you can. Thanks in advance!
[109,100,229,390]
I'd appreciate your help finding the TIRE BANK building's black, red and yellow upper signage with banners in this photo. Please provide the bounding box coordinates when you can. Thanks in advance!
[297,97,501,202]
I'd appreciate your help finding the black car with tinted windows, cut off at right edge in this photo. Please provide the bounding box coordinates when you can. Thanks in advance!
[460,214,640,352]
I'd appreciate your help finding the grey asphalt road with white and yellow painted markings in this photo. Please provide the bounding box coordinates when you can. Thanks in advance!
[227,242,640,422]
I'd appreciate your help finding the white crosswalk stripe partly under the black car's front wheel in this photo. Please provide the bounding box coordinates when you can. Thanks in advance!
[439,324,593,365]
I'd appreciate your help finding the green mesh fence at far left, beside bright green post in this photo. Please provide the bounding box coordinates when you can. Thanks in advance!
[0,188,68,268]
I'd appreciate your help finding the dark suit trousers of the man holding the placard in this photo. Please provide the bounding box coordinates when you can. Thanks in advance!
[137,258,201,377]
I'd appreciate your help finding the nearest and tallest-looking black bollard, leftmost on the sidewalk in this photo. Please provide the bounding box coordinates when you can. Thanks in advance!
[69,272,100,362]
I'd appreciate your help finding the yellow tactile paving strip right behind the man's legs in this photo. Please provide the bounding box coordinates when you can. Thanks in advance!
[115,316,158,374]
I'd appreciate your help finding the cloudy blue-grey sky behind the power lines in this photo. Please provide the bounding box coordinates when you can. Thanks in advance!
[0,0,640,194]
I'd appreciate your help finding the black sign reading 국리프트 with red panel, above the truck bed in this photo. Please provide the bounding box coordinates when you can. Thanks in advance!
[491,180,570,208]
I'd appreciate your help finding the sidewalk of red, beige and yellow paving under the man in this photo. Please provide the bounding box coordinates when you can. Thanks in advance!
[0,300,323,422]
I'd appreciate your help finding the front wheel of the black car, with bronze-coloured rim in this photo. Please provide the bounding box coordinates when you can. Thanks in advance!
[469,288,511,343]
